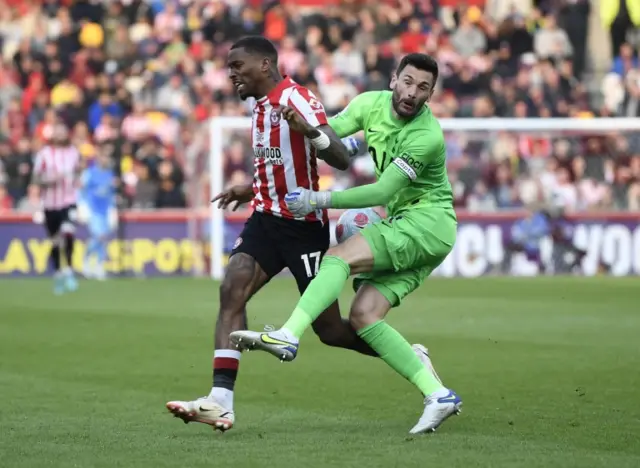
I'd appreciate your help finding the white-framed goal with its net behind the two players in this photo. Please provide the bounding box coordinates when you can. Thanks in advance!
[206,117,640,279]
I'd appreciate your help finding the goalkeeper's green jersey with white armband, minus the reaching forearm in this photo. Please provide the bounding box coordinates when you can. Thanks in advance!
[329,91,453,216]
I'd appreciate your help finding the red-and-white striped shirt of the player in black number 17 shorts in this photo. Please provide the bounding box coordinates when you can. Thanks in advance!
[251,76,328,222]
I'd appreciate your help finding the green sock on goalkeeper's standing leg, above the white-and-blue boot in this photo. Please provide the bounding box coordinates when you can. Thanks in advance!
[358,320,443,396]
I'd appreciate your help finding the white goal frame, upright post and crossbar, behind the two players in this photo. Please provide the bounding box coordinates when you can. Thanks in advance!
[209,117,640,280]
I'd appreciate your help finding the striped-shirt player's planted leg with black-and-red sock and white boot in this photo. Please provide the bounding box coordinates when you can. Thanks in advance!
[167,253,269,431]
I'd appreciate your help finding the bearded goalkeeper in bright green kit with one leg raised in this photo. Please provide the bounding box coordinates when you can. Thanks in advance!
[230,54,462,434]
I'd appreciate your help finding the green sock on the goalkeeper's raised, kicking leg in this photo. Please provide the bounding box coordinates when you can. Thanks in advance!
[282,255,351,339]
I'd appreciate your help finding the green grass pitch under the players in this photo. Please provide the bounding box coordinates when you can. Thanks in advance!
[0,278,640,468]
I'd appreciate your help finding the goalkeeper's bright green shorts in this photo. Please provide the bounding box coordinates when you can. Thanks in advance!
[353,208,458,307]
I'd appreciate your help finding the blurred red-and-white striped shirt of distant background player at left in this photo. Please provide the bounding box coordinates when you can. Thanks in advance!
[33,145,80,210]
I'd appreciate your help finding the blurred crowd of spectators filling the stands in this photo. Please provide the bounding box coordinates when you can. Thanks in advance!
[0,0,640,212]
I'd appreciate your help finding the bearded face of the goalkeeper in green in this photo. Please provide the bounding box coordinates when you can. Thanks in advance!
[391,65,434,118]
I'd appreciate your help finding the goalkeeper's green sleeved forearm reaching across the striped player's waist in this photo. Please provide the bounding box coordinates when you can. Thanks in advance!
[331,164,410,209]
